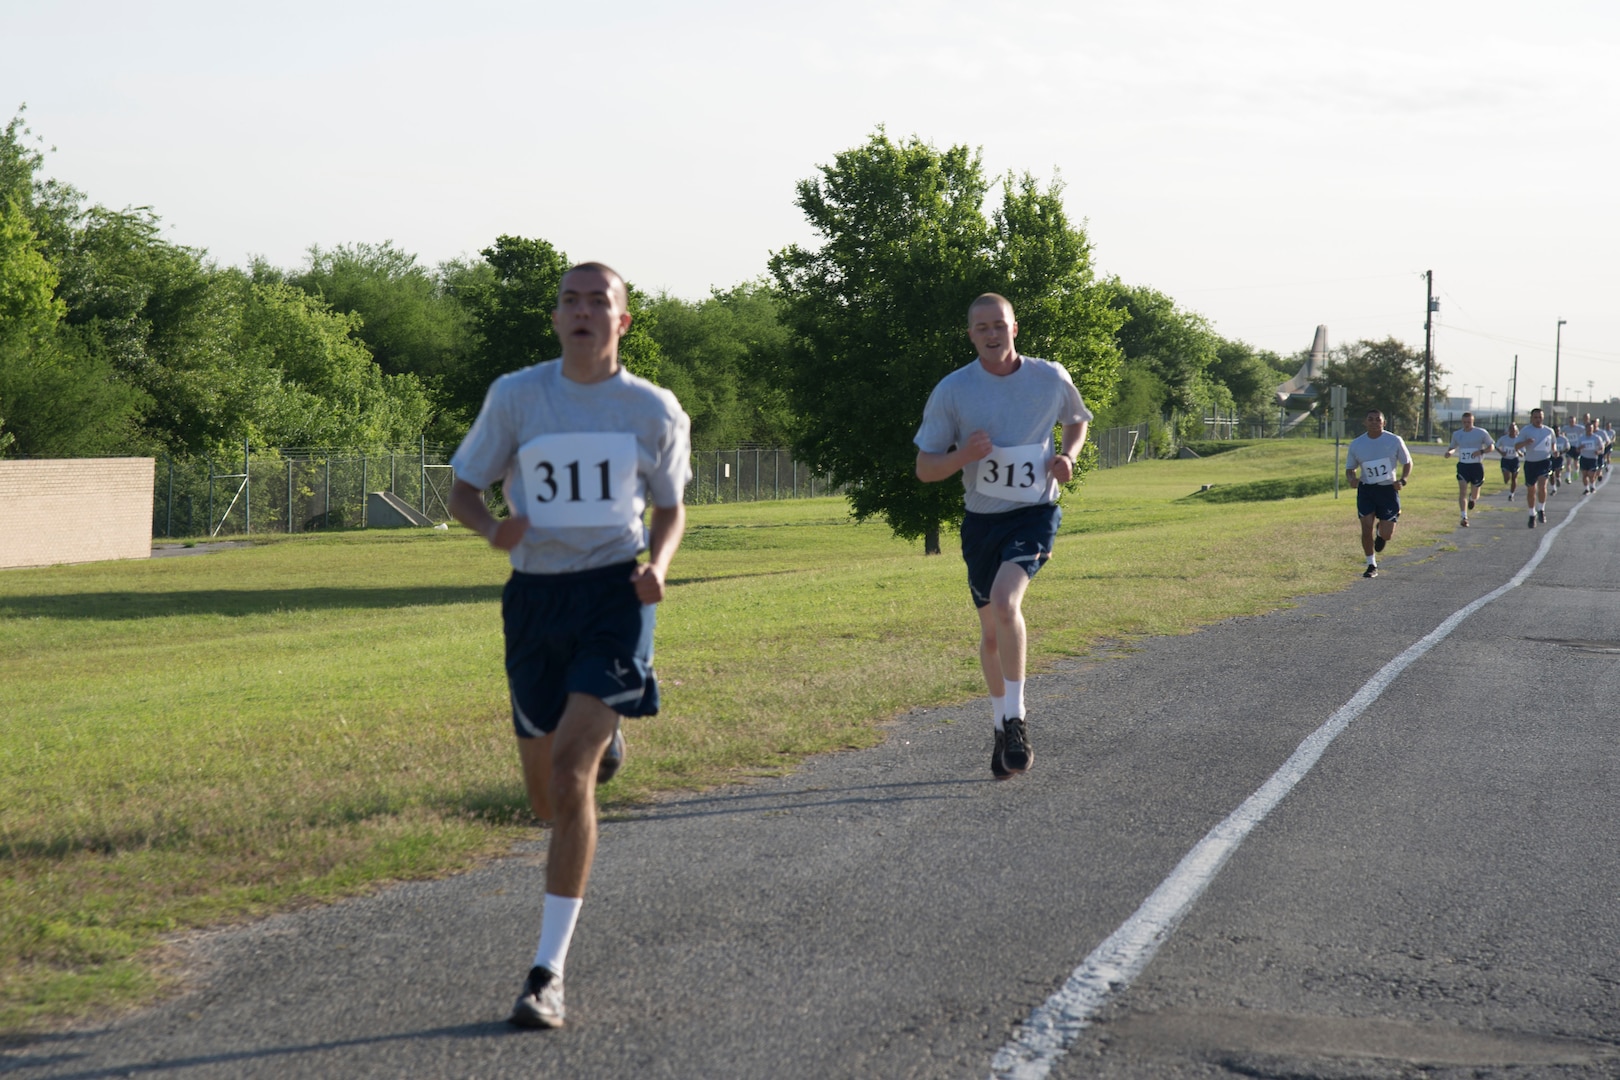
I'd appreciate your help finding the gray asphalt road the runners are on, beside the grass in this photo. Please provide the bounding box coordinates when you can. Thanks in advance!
[0,476,1620,1080]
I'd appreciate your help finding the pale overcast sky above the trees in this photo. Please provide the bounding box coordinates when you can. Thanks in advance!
[0,0,1620,406]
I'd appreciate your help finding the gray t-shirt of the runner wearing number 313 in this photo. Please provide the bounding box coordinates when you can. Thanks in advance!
[914,356,1092,513]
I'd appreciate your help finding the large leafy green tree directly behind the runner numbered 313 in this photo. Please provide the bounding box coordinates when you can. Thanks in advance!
[771,130,1118,552]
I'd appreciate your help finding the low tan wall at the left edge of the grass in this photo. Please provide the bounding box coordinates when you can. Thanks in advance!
[0,458,154,567]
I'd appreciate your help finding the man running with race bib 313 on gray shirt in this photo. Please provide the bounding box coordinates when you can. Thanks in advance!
[915,293,1092,779]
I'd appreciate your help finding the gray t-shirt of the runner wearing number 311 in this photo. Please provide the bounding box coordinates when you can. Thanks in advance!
[450,359,692,573]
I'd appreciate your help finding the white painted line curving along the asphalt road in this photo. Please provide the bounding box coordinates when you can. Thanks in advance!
[990,502,1586,1080]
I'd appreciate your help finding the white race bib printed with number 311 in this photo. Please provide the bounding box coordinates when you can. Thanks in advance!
[517,431,640,529]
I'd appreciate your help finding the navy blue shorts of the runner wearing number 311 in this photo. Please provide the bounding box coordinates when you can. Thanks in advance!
[501,562,658,738]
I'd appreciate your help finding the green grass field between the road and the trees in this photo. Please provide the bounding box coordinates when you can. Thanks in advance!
[0,440,1470,1033]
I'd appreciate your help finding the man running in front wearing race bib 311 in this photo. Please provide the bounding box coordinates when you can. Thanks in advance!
[450,262,692,1028]
